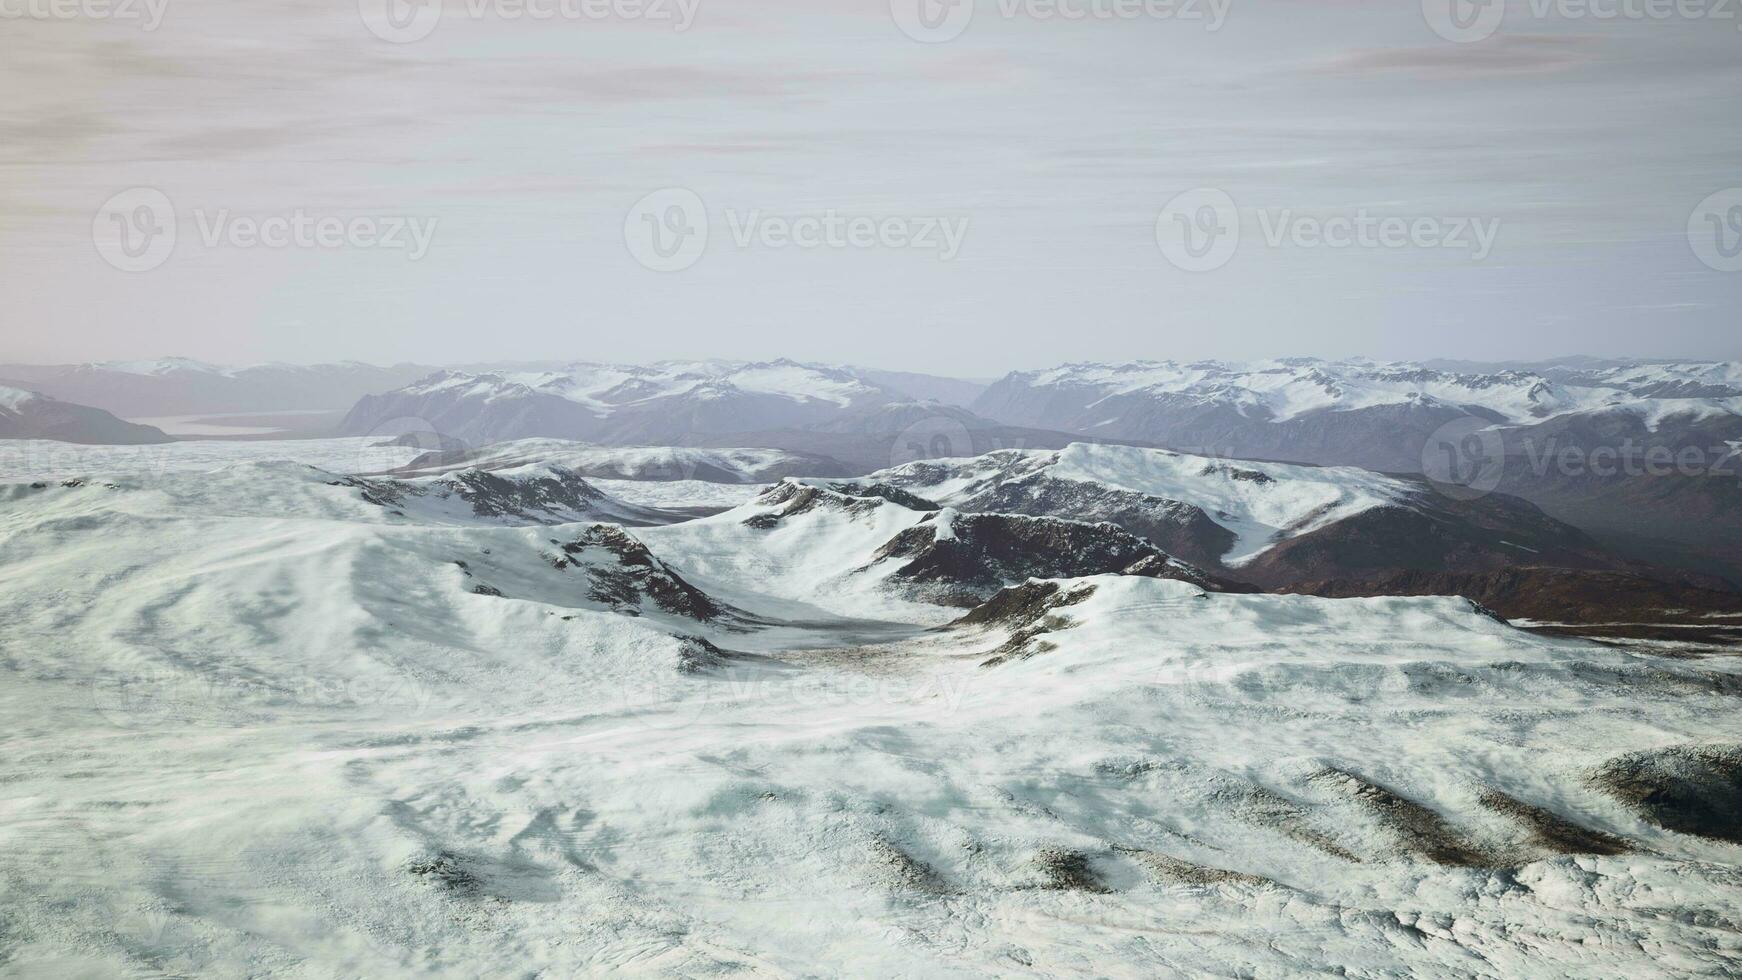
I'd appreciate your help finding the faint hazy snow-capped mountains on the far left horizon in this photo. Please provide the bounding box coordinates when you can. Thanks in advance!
[0,357,434,418]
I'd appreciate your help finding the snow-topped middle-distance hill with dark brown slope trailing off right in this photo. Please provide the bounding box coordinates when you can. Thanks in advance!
[861,444,1742,618]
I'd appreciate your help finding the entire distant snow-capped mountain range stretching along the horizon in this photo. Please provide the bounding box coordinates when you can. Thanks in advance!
[13,359,1742,581]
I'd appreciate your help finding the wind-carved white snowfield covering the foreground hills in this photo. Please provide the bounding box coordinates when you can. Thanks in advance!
[0,449,1742,977]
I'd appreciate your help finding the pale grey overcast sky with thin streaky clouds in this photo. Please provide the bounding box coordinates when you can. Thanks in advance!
[0,0,1742,376]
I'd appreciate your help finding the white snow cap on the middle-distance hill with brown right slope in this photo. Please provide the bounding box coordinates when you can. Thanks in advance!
[862,442,1418,566]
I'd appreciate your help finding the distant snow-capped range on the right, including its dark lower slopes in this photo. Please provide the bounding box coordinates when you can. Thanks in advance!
[974,360,1742,581]
